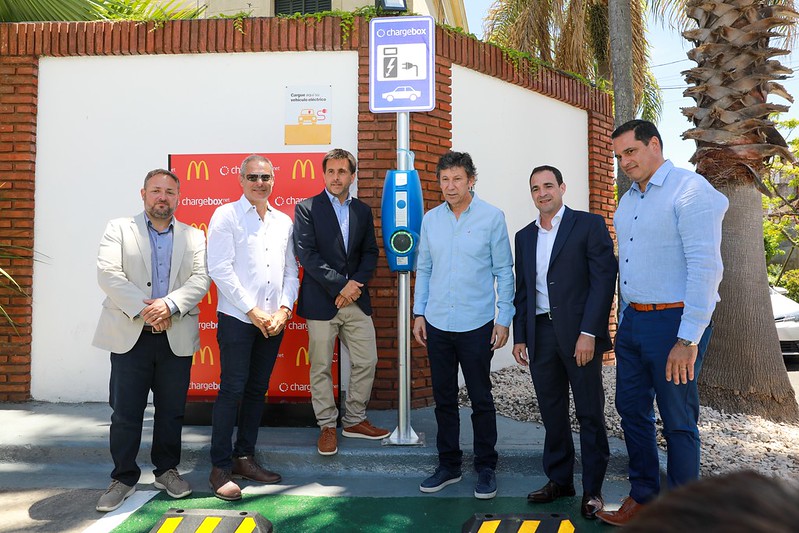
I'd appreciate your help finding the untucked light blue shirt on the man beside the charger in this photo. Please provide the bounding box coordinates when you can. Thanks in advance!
[413,195,514,332]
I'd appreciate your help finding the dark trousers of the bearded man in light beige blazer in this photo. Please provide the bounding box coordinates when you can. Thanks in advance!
[108,332,192,486]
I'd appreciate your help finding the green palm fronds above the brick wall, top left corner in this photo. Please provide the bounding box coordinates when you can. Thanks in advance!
[0,0,205,22]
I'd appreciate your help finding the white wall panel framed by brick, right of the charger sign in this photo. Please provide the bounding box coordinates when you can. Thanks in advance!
[452,65,588,369]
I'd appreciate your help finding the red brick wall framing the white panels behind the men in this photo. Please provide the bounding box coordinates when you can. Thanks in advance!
[0,17,614,409]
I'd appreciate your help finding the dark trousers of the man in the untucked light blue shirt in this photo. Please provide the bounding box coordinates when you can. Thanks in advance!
[426,322,497,472]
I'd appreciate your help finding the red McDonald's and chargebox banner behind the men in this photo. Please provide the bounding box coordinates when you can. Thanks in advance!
[169,153,338,402]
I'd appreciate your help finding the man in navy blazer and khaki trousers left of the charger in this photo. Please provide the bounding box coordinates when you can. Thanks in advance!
[294,148,390,455]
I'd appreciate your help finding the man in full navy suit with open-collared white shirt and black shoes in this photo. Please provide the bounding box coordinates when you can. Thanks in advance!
[513,166,618,518]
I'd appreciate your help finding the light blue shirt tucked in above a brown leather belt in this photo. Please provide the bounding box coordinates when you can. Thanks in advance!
[613,160,729,342]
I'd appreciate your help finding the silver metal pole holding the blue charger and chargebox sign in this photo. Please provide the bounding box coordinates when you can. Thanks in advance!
[383,111,424,445]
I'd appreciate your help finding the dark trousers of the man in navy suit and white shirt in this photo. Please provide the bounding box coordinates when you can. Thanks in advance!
[530,315,610,495]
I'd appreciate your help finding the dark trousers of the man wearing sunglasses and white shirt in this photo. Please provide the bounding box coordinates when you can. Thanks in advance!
[211,313,283,470]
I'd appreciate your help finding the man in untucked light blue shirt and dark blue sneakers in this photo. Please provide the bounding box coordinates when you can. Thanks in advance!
[413,152,514,499]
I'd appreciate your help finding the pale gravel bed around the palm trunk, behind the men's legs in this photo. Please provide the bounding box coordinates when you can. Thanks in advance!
[460,365,799,478]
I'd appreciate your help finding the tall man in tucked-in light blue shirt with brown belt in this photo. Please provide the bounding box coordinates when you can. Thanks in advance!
[597,120,729,526]
